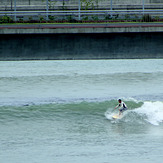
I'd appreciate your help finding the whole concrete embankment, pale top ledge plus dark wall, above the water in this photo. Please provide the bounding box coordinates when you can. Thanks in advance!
[0,23,163,60]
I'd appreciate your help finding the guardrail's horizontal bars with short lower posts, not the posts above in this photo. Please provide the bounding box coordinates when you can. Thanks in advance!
[0,9,163,21]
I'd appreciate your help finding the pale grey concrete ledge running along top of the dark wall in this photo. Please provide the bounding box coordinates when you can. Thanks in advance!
[0,23,163,34]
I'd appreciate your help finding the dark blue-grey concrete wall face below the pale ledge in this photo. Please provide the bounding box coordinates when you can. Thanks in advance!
[0,33,163,60]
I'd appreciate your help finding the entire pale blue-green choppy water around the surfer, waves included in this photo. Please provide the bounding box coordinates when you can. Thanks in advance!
[0,59,163,163]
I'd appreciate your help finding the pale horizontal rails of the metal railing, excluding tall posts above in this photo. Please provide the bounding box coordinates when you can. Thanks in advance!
[0,9,163,20]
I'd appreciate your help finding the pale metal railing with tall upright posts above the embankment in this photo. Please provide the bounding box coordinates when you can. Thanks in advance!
[0,0,163,22]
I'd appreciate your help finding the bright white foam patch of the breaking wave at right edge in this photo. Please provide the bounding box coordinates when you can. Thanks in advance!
[134,101,163,125]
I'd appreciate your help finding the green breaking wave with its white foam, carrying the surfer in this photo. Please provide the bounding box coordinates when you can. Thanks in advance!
[0,98,163,125]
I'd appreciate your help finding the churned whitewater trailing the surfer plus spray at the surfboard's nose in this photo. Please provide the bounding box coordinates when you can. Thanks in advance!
[105,101,163,125]
